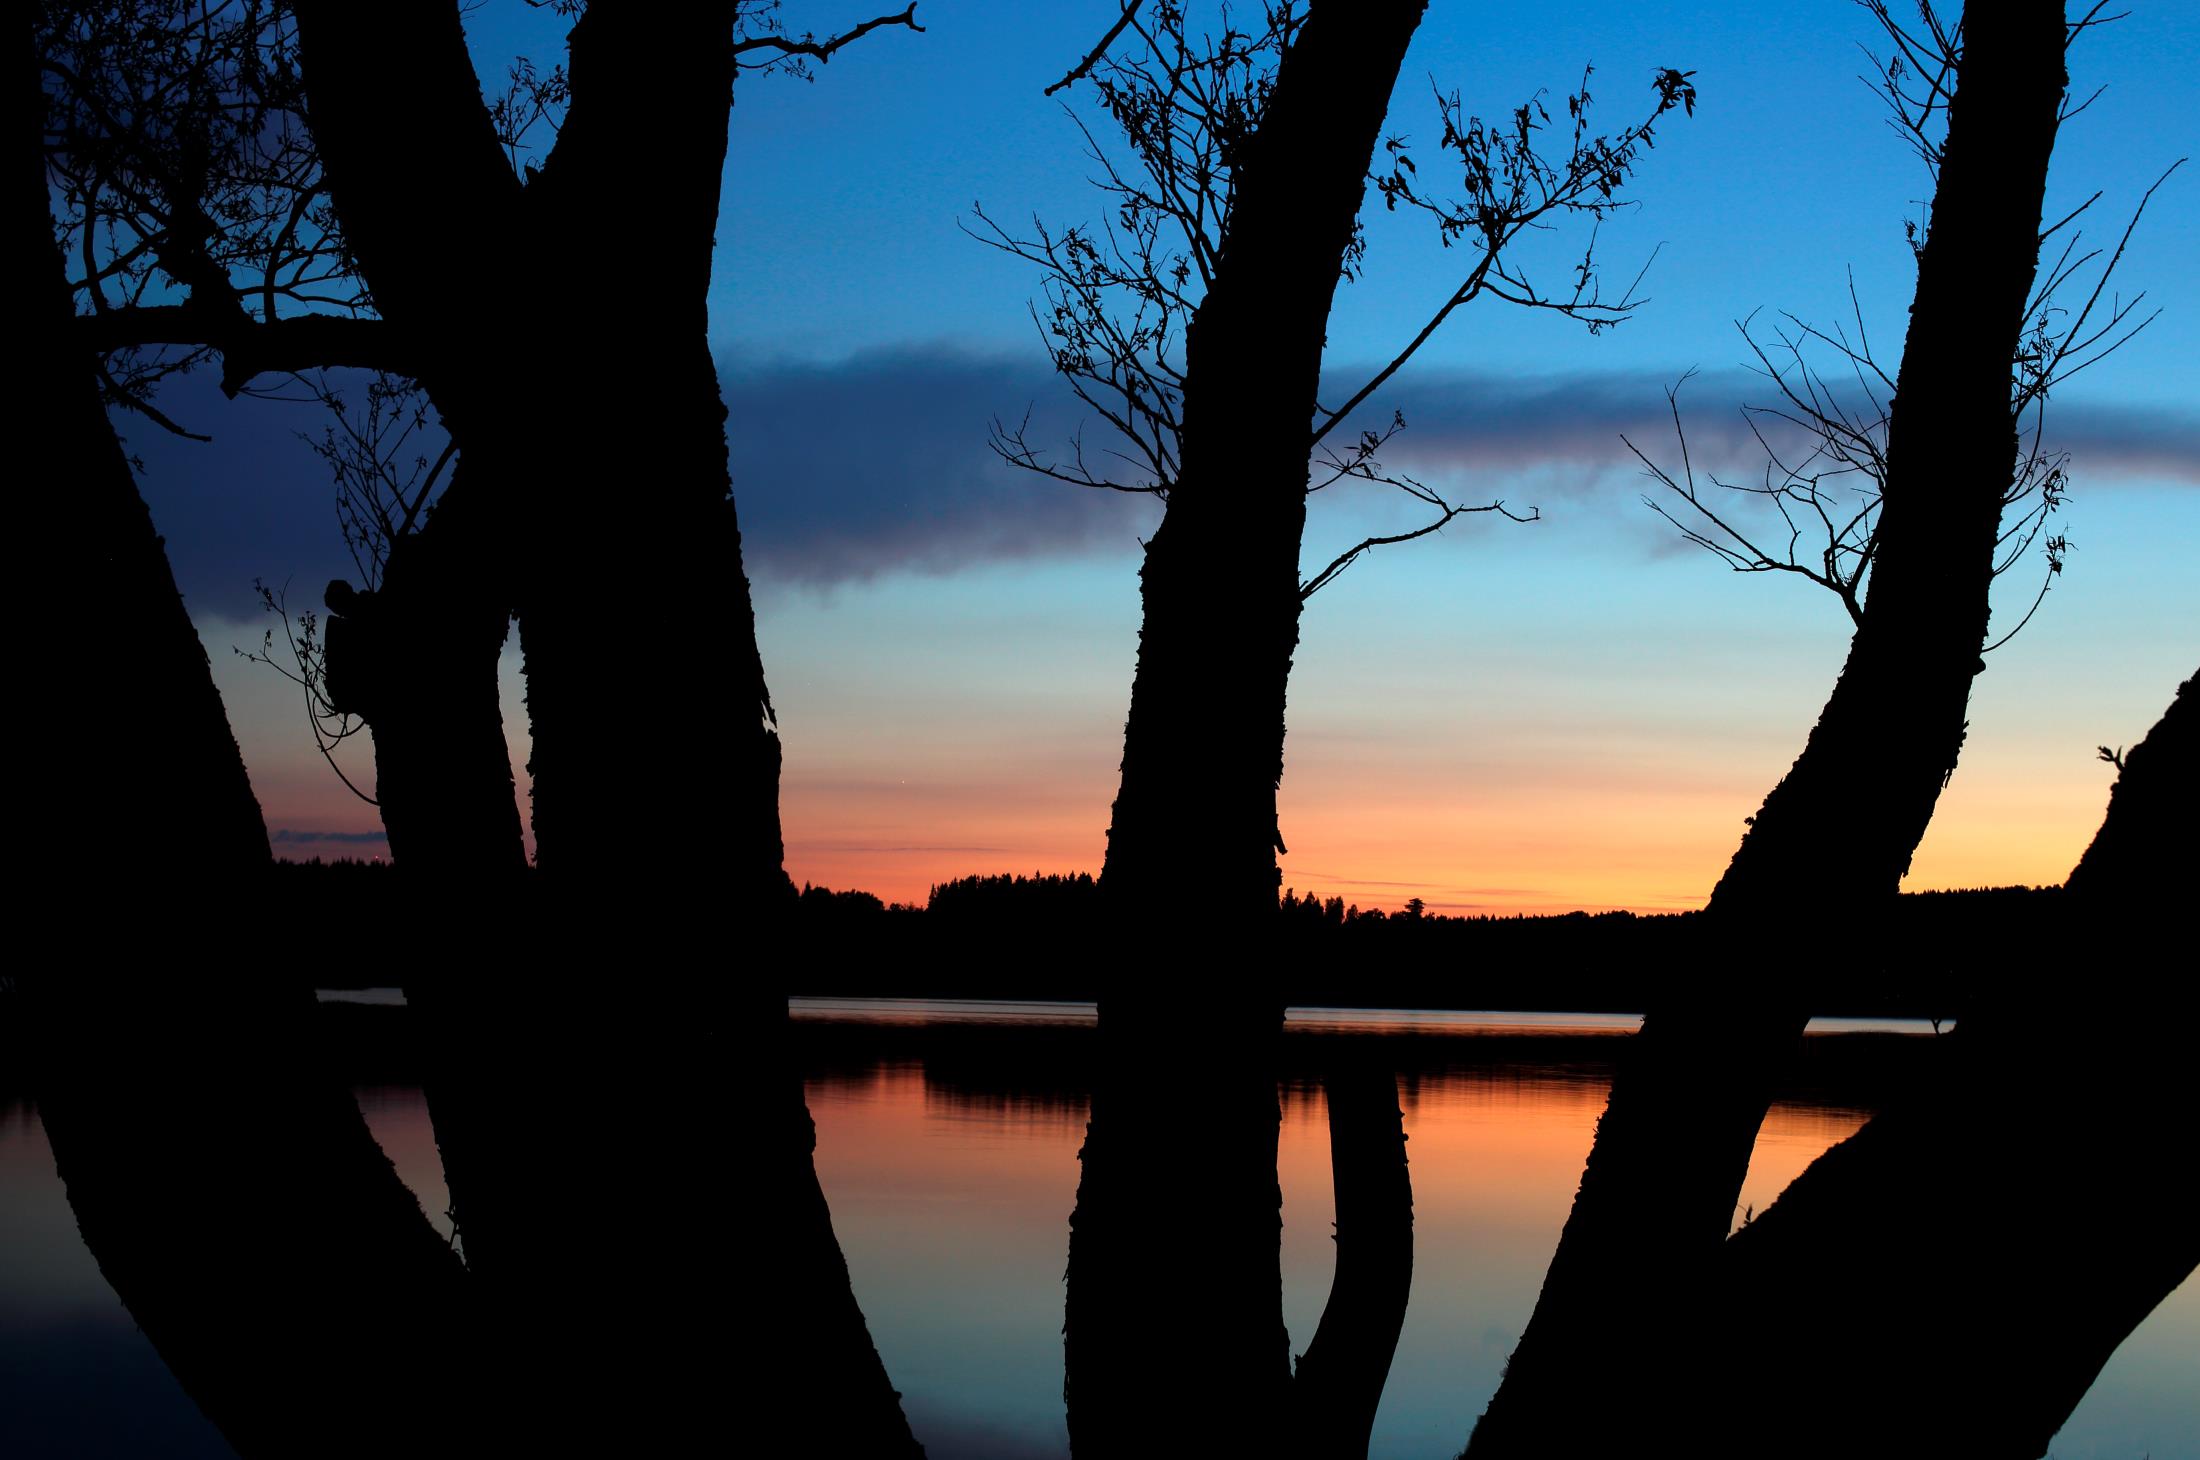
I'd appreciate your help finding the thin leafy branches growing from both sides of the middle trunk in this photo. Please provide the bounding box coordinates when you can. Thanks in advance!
[966,2,1696,596]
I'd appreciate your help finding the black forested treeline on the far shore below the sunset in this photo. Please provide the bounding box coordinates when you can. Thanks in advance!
[275,860,2068,1018]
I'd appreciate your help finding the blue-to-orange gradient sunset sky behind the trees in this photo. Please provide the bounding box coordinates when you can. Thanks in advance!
[117,0,2200,913]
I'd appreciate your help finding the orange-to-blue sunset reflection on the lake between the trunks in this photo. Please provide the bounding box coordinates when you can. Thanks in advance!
[807,1036,1863,1456]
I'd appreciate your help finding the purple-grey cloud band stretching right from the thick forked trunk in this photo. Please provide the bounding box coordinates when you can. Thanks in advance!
[722,345,2200,587]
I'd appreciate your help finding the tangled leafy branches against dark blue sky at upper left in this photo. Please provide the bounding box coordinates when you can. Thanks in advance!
[35,0,924,431]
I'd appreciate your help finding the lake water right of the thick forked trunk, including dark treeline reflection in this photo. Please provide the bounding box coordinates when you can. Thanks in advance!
[796,1000,2200,1460]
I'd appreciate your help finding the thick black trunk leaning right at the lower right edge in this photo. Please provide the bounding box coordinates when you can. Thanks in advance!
[1714,682,2200,1460]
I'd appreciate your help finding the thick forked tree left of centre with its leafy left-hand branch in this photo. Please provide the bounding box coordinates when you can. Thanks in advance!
[42,4,932,1453]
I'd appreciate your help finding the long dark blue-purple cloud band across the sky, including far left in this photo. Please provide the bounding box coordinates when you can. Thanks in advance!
[117,345,2200,622]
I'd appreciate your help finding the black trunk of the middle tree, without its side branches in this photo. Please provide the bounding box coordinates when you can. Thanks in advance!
[1063,0,1423,1460]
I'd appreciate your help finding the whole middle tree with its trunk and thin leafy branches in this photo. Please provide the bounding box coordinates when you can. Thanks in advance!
[979,0,1694,1456]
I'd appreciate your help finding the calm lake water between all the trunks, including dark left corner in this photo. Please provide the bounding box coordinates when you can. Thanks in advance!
[0,1000,2200,1460]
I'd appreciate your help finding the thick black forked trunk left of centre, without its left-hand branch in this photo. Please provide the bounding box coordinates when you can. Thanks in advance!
[301,14,915,1424]
